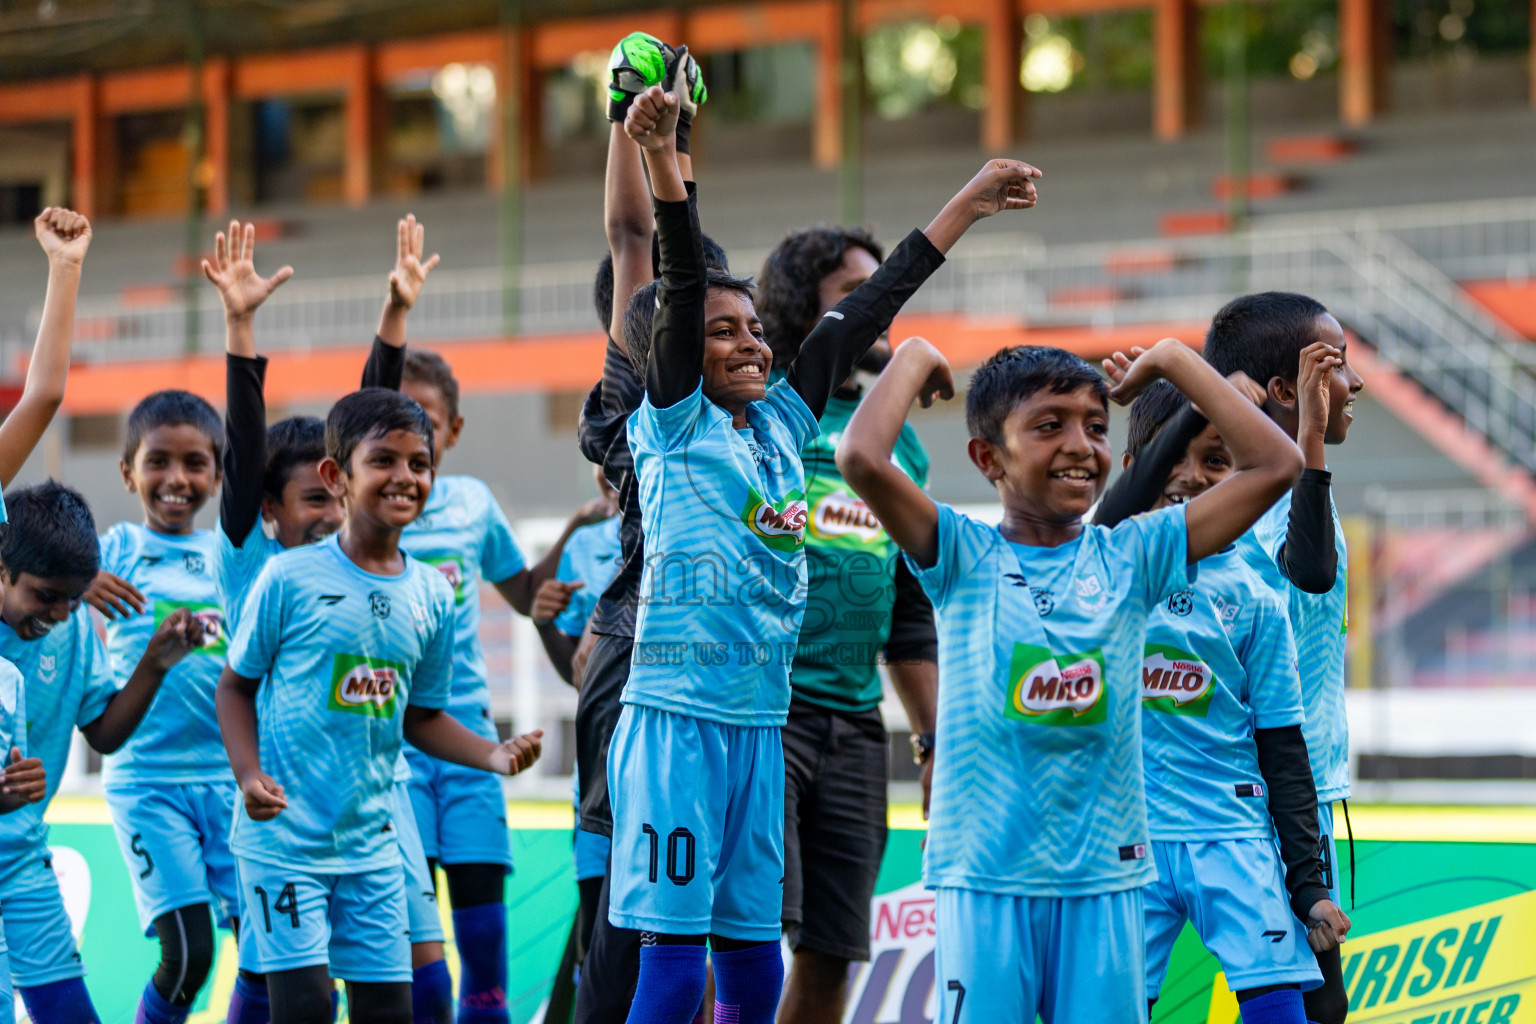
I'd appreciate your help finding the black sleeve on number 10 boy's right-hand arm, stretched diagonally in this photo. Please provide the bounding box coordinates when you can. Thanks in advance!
[785,227,945,419]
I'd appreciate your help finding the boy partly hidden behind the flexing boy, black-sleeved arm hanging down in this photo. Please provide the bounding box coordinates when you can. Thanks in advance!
[1095,380,1349,1024]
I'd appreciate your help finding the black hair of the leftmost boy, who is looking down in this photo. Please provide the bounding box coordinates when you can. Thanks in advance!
[0,481,101,583]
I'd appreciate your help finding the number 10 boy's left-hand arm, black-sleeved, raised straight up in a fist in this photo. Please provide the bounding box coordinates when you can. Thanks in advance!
[624,86,708,408]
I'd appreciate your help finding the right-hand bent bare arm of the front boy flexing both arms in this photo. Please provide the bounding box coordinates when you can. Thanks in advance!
[1109,338,1301,562]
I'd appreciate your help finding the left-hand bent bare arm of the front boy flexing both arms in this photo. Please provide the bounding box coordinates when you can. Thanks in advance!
[837,338,954,568]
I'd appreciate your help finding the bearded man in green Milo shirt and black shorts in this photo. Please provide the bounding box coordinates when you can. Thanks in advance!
[757,226,938,1024]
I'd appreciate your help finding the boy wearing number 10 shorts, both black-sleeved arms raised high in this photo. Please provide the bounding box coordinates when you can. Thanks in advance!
[608,80,1038,1024]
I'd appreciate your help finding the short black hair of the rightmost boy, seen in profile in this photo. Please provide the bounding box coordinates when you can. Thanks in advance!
[1204,292,1329,388]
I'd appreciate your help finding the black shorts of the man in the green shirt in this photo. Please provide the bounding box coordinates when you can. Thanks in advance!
[783,700,886,960]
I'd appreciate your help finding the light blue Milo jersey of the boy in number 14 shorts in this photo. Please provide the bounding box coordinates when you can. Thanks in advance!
[229,536,453,874]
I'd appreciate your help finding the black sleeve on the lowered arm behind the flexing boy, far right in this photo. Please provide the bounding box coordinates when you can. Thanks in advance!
[1253,725,1329,921]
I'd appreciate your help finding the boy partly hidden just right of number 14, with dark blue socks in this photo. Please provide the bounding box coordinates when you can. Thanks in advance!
[401,348,602,1024]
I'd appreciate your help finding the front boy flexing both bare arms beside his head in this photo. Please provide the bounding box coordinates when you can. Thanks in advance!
[837,339,1301,1024]
